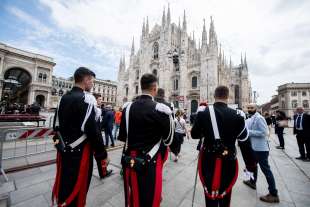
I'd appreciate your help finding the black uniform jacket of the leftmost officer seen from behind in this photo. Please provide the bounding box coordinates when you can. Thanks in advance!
[54,87,107,159]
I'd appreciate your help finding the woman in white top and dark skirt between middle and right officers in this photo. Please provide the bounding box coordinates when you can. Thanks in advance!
[170,110,188,162]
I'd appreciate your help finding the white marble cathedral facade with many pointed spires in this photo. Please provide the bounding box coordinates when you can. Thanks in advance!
[117,8,252,113]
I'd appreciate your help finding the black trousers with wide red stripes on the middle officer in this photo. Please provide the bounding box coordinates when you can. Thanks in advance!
[123,153,164,207]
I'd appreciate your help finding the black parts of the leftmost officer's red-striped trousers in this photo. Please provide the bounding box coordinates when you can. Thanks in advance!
[58,149,93,207]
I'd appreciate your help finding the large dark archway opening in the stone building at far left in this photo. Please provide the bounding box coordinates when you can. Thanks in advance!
[1,67,31,105]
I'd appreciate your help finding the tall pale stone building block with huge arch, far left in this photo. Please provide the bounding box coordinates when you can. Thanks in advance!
[0,43,56,107]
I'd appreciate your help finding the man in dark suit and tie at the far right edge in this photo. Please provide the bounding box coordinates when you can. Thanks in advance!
[294,107,310,161]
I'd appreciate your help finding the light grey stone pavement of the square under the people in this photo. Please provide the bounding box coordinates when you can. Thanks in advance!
[1,130,310,207]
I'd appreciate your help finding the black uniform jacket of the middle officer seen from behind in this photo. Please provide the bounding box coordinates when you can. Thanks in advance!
[118,95,171,152]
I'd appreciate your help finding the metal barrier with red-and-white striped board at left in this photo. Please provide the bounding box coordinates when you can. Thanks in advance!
[0,126,55,180]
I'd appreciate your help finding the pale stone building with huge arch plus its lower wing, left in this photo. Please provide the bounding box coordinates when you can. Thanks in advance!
[0,43,117,108]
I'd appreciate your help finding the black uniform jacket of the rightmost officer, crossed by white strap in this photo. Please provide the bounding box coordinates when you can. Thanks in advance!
[191,102,248,151]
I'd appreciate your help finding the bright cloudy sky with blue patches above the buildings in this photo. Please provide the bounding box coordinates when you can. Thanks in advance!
[0,0,310,103]
